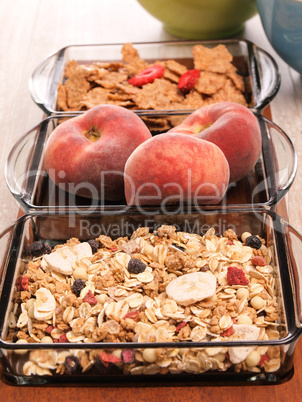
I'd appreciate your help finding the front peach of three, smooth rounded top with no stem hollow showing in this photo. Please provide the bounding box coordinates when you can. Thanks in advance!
[125,133,229,205]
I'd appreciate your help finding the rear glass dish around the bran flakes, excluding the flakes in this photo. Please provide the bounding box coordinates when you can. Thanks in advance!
[29,39,280,115]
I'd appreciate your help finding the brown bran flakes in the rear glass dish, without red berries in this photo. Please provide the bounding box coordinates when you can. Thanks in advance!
[58,43,247,131]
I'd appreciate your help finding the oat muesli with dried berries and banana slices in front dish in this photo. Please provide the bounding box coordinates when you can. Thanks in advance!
[7,225,282,375]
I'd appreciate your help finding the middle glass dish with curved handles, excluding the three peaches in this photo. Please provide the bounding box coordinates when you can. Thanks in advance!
[6,112,297,212]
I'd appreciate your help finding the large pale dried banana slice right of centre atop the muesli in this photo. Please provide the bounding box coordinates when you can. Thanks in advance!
[166,271,216,306]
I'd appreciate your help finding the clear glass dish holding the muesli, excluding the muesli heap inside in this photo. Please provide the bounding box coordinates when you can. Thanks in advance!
[0,209,302,386]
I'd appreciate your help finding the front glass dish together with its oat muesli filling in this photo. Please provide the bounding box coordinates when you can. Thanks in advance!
[0,209,302,386]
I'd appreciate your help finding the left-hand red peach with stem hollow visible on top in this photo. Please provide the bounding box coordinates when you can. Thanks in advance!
[45,105,151,201]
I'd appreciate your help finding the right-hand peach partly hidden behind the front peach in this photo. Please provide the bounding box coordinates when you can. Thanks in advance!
[168,102,262,182]
